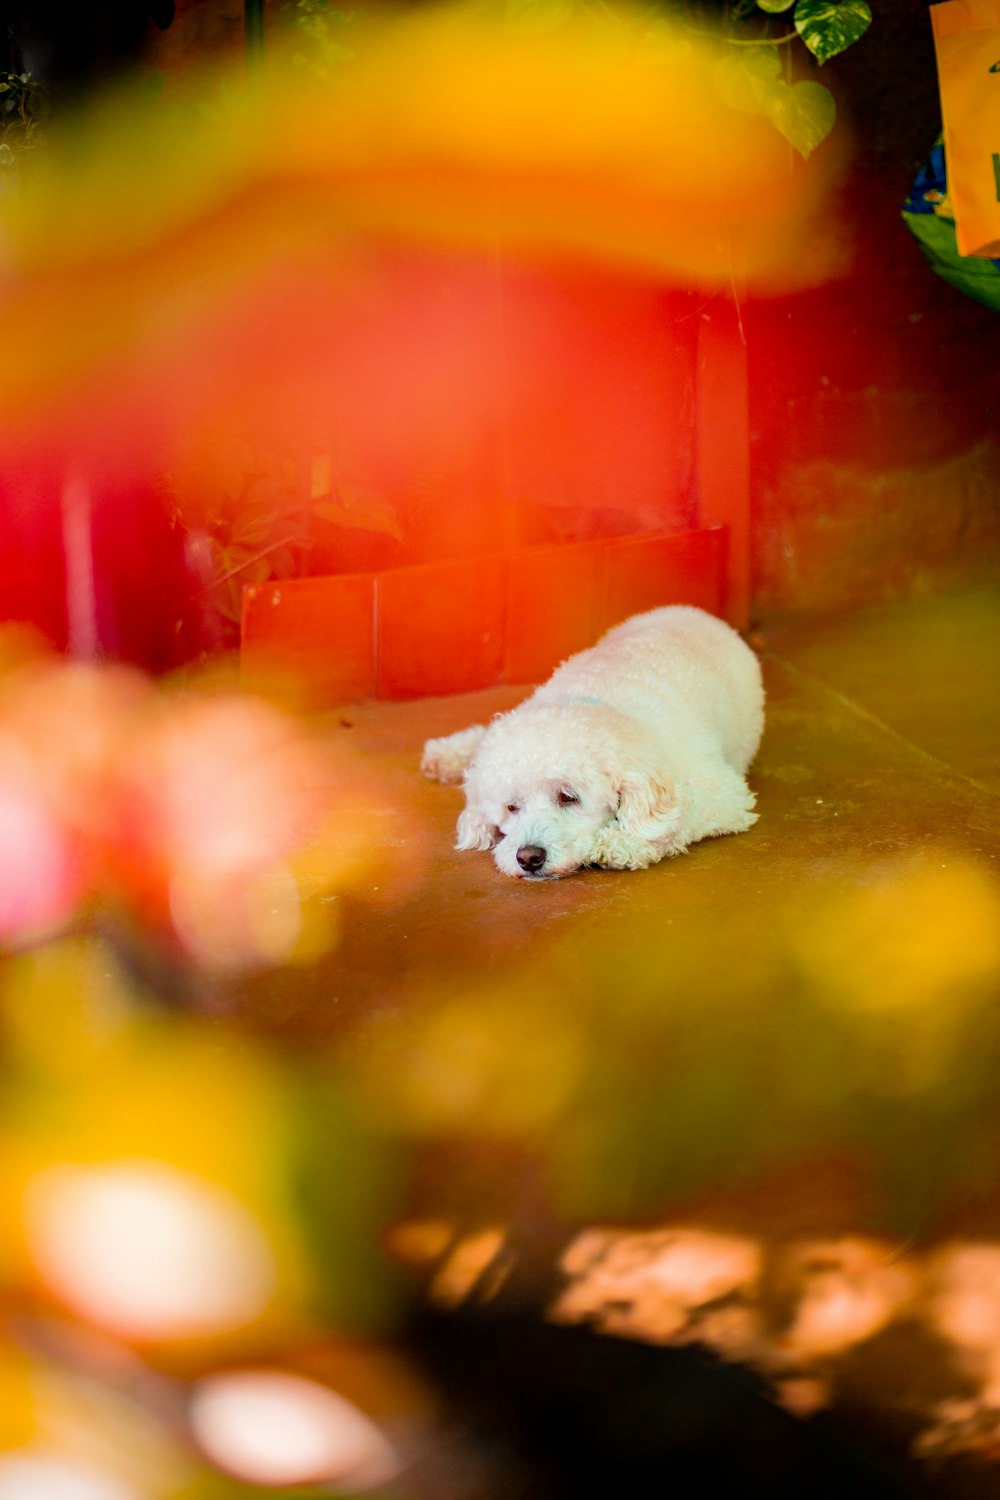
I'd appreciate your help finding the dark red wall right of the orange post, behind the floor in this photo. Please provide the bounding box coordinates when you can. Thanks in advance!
[745,0,1000,614]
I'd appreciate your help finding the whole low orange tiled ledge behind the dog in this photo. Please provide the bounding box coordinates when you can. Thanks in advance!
[241,527,729,708]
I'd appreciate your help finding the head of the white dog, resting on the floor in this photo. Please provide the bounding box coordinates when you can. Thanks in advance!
[456,702,681,879]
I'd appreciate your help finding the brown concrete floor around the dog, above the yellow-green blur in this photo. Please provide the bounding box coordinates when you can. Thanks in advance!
[277,590,1000,1032]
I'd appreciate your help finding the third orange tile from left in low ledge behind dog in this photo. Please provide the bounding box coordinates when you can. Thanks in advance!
[504,542,604,683]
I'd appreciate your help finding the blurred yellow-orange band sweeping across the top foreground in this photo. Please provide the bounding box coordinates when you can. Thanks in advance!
[0,8,837,462]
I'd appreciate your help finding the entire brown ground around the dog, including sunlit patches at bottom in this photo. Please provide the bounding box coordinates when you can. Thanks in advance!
[239,590,1000,1496]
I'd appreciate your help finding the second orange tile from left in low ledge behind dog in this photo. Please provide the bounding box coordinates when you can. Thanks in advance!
[376,557,507,698]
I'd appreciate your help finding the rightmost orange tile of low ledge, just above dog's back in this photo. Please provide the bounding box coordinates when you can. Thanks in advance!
[598,527,729,630]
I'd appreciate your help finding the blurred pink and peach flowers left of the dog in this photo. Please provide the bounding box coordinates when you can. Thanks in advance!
[0,659,364,968]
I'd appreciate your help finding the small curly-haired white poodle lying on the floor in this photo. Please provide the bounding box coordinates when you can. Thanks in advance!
[421,605,763,881]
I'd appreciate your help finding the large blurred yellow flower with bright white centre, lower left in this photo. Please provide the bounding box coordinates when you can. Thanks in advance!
[0,1008,309,1343]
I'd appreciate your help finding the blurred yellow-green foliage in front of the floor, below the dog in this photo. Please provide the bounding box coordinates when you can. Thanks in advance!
[340,849,1000,1235]
